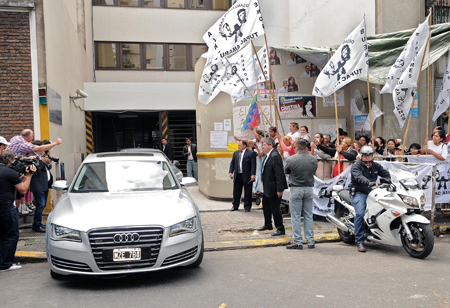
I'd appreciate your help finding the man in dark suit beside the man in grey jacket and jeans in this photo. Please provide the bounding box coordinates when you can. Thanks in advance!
[258,137,288,236]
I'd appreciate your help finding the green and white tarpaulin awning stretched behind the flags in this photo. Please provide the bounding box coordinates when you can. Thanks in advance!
[272,23,450,85]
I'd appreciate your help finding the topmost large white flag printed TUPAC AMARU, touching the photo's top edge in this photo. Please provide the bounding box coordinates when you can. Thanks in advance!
[203,0,265,58]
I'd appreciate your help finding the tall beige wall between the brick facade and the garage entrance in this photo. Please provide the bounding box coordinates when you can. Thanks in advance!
[43,0,93,181]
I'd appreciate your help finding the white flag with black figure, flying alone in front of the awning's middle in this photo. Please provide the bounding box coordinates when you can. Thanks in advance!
[313,21,369,97]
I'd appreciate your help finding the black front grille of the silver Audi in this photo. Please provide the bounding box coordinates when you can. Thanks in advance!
[88,226,163,271]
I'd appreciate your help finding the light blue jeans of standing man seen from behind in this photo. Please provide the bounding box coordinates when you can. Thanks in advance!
[289,187,314,245]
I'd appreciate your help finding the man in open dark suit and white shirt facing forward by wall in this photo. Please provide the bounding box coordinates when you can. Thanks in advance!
[229,141,256,212]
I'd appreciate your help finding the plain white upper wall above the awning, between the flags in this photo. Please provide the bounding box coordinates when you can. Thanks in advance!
[289,0,375,47]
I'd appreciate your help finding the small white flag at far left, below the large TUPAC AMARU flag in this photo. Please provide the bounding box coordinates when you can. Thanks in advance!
[198,58,226,105]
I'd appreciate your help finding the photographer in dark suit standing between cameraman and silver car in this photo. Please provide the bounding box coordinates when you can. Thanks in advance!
[28,140,58,233]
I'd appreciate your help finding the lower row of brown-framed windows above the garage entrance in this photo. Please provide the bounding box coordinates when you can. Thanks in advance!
[95,42,208,71]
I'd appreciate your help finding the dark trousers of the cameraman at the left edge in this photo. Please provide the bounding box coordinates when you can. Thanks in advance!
[0,204,19,270]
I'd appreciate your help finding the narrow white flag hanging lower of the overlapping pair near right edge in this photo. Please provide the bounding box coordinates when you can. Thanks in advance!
[392,40,428,128]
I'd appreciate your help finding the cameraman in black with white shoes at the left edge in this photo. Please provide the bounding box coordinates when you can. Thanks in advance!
[0,151,36,271]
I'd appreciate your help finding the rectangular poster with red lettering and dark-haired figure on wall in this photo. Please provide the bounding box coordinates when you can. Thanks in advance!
[279,95,317,118]
